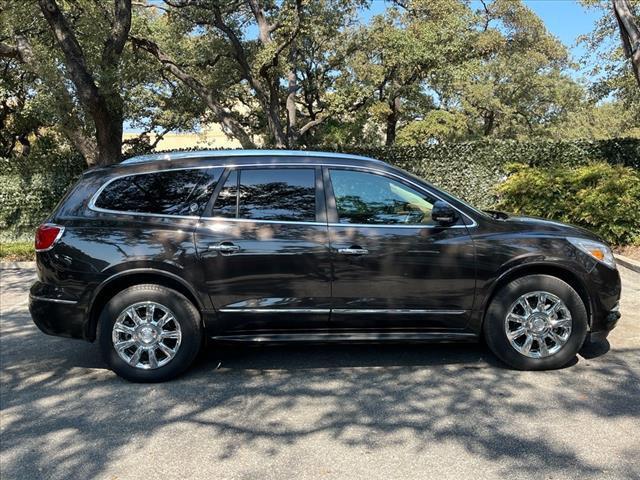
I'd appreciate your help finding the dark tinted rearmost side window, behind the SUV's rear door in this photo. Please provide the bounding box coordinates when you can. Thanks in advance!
[95,168,222,215]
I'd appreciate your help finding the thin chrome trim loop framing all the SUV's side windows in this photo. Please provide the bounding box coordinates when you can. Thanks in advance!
[89,162,478,228]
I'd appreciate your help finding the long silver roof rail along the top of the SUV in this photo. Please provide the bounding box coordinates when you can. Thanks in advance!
[121,150,381,165]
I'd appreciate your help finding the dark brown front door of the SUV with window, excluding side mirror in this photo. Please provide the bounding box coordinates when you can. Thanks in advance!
[324,167,475,333]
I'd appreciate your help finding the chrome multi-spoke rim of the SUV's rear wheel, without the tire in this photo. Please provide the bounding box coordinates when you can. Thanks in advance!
[111,302,182,370]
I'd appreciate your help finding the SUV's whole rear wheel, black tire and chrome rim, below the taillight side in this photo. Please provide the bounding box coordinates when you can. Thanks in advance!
[97,284,203,383]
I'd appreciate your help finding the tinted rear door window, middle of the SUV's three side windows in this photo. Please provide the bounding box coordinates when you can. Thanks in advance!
[213,168,316,222]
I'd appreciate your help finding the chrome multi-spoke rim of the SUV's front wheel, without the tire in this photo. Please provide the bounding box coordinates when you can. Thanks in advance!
[504,291,572,358]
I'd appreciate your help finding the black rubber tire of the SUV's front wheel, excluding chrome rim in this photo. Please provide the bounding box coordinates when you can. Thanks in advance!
[483,275,588,370]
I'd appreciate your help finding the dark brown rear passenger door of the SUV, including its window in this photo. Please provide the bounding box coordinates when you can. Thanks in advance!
[195,166,331,335]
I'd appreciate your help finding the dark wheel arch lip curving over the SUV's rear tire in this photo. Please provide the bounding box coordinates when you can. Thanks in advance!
[85,268,204,342]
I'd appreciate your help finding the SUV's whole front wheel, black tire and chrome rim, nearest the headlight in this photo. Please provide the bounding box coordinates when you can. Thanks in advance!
[483,275,588,370]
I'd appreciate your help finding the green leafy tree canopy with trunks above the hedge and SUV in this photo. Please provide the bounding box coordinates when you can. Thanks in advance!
[0,0,640,165]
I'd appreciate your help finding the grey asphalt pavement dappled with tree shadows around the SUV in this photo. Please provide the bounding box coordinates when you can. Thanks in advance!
[0,270,640,480]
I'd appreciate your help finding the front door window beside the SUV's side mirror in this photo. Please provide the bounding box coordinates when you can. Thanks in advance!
[330,169,433,225]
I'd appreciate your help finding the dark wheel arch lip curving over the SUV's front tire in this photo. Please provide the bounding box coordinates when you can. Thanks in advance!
[481,263,594,328]
